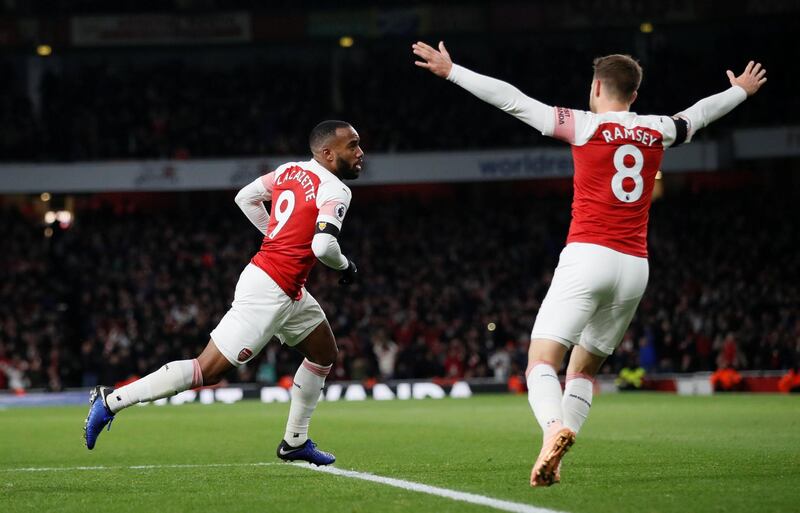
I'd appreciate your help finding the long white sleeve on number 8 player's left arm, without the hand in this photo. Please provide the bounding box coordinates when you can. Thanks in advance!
[447,64,555,136]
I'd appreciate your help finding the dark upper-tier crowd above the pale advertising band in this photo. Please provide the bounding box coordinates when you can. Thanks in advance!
[0,18,800,161]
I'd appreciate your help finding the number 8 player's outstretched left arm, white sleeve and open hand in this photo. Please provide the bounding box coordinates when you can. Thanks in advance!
[411,41,555,135]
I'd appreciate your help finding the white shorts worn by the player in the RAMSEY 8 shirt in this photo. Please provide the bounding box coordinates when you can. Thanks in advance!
[531,242,649,356]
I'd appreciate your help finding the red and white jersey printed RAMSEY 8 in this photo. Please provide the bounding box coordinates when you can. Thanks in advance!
[545,107,676,257]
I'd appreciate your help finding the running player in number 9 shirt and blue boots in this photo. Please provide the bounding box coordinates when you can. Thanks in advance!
[85,120,364,465]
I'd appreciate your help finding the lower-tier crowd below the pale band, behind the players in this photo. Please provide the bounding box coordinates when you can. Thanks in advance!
[0,183,800,390]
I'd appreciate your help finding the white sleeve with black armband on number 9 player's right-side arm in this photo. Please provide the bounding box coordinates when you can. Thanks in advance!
[311,180,352,271]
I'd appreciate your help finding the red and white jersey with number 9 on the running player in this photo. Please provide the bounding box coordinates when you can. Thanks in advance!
[251,160,352,300]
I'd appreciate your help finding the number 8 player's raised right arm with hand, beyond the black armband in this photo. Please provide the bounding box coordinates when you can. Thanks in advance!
[675,61,767,140]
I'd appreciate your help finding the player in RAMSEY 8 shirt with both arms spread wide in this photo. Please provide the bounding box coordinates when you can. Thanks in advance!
[412,42,767,486]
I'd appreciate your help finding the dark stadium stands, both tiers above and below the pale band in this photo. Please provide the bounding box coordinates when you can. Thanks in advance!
[0,0,800,390]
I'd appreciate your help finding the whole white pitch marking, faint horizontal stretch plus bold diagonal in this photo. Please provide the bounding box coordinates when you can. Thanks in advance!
[6,462,563,513]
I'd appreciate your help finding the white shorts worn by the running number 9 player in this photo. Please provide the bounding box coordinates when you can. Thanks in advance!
[211,263,325,367]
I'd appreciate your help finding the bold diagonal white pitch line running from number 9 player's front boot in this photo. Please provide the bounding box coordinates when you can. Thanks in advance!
[296,463,563,513]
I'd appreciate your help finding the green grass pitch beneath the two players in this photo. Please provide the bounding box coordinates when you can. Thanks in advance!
[0,393,800,513]
